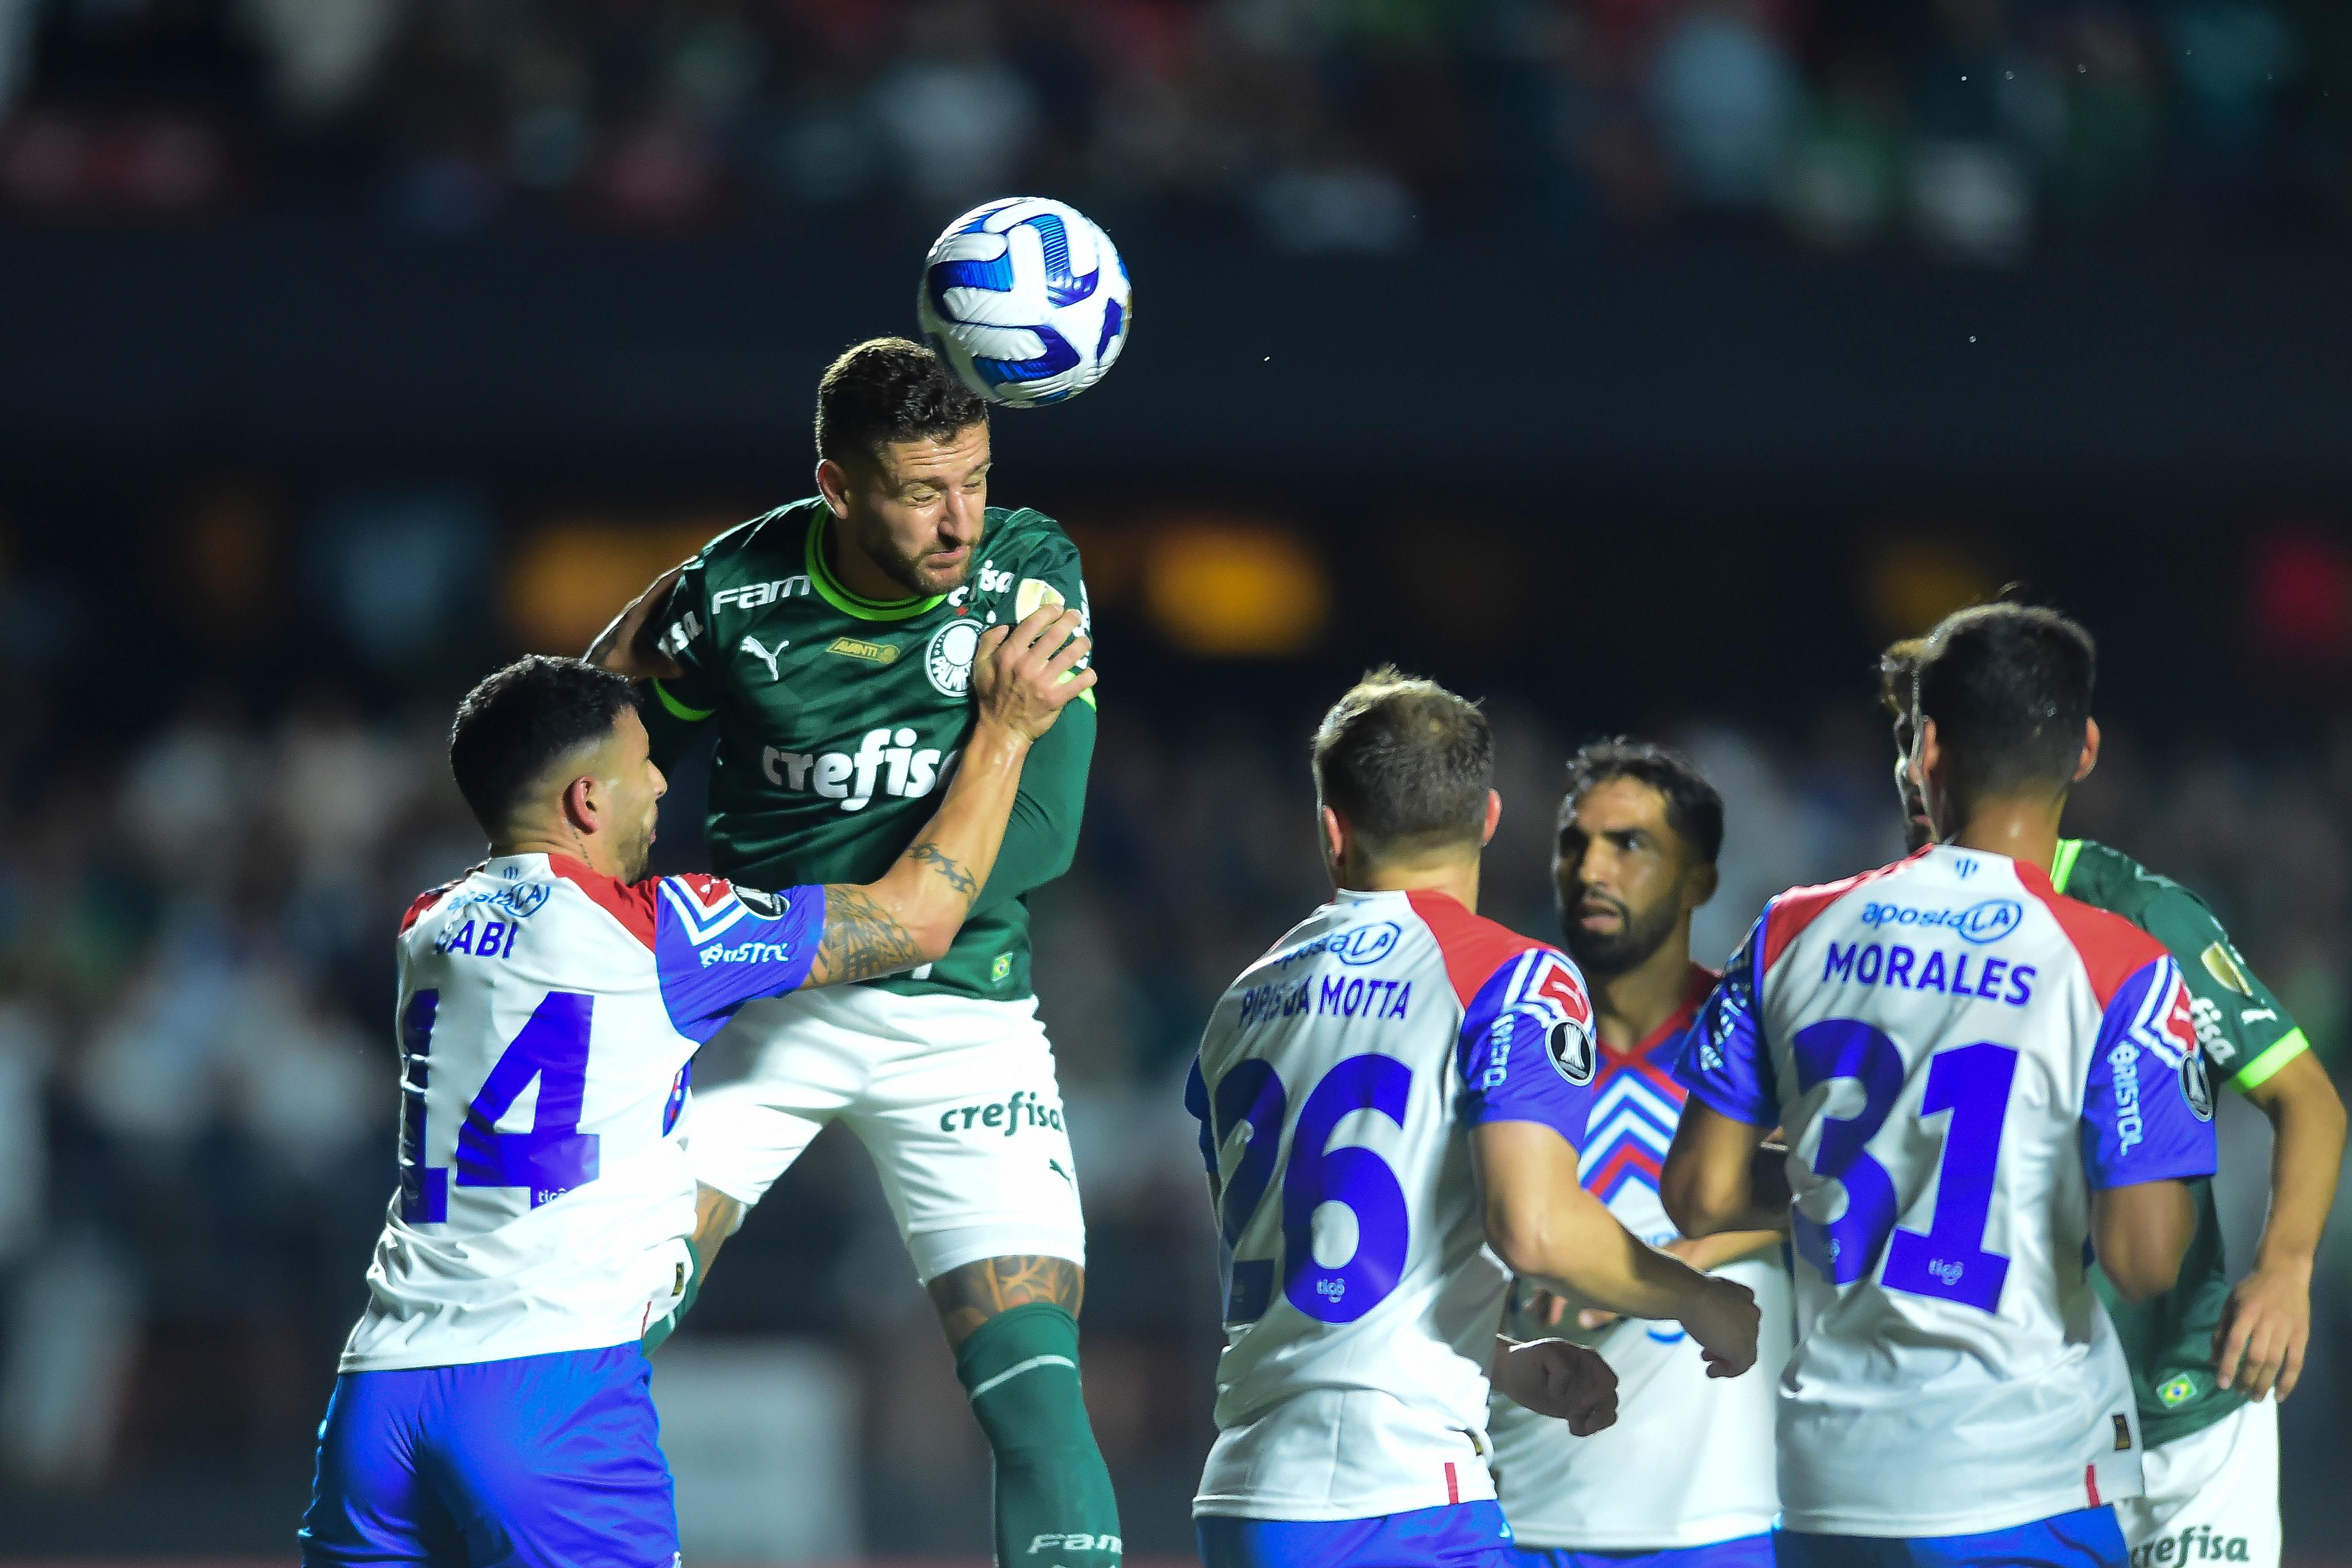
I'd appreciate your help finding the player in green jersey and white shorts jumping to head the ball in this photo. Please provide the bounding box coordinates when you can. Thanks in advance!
[588,338,1120,1568]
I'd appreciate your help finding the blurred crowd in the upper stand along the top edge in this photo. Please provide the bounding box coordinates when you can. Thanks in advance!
[0,0,2352,263]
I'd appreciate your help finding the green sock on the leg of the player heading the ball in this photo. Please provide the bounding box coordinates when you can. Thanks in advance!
[955,1303,1120,1568]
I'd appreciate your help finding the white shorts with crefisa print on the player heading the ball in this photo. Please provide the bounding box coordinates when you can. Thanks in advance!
[687,985,1087,1284]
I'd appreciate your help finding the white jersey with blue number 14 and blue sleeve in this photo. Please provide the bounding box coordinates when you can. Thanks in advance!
[341,856,825,1373]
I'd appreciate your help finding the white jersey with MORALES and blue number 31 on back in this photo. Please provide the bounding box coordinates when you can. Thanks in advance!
[1679,844,2213,1537]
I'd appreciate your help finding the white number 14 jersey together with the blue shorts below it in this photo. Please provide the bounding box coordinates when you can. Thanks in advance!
[301,856,825,1568]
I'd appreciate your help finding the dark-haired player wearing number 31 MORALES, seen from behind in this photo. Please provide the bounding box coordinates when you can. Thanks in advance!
[1661,604,2213,1568]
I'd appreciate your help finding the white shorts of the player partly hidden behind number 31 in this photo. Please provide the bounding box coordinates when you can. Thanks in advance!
[2114,1399,2281,1568]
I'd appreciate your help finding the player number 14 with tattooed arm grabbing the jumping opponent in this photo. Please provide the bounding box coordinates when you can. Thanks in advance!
[301,609,1091,1568]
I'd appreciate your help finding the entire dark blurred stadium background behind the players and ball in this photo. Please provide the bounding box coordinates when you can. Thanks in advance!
[0,0,2352,1561]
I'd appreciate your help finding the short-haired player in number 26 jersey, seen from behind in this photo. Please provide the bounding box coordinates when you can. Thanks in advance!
[1185,670,1757,1568]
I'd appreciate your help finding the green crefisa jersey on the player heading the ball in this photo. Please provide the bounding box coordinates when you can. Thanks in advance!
[649,498,1094,1002]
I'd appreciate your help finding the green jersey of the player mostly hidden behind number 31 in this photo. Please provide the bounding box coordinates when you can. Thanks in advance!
[2051,839,2309,1448]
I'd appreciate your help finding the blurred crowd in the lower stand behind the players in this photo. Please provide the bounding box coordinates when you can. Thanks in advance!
[0,606,2352,1549]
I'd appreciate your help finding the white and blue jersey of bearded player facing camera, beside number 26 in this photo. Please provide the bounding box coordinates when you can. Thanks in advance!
[1491,964,1790,1568]
